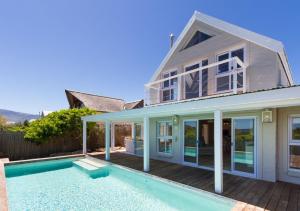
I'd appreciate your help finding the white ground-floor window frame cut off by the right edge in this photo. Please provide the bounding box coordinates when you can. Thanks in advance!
[287,114,300,173]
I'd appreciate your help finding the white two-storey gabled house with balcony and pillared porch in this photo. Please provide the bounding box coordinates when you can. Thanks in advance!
[82,11,300,193]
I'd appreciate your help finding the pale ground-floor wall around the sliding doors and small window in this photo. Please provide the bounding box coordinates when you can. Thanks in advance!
[150,110,277,181]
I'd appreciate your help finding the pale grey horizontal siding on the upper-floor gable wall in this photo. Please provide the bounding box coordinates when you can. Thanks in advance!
[157,26,289,102]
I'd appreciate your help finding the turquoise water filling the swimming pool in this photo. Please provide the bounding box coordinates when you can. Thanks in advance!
[5,159,234,211]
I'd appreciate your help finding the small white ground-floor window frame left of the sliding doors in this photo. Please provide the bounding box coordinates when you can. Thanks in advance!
[156,120,174,156]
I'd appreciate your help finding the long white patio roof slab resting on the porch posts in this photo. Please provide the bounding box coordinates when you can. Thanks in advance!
[82,86,300,122]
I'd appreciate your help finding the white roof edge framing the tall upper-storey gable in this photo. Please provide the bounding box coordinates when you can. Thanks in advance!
[150,11,294,85]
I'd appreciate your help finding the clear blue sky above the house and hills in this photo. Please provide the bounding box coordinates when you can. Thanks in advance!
[0,0,300,113]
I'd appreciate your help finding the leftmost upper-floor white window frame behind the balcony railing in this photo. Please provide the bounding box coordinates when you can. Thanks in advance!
[160,69,178,102]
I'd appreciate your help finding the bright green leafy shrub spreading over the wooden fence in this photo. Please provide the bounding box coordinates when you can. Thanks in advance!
[24,108,96,143]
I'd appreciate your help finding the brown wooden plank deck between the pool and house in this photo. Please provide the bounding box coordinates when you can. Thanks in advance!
[94,152,300,211]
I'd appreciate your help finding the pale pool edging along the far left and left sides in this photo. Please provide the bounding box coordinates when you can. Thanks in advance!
[0,154,85,211]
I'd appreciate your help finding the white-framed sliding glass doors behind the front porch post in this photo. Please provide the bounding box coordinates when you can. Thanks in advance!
[183,117,256,177]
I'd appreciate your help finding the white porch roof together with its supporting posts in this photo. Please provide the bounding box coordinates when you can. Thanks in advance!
[82,86,300,193]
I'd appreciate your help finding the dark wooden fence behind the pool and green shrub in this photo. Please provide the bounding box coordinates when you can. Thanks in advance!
[0,125,131,160]
